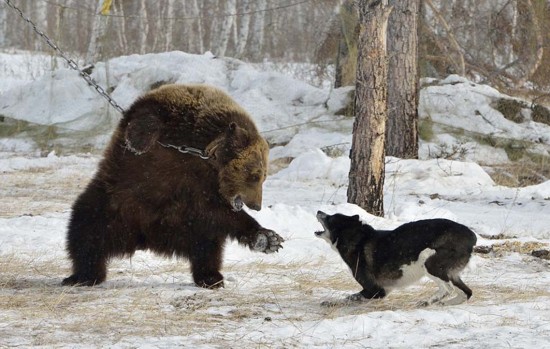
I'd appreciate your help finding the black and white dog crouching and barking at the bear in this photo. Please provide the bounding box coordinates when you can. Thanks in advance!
[315,211,477,306]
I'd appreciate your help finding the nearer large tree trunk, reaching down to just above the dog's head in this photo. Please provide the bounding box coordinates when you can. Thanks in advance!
[348,0,391,216]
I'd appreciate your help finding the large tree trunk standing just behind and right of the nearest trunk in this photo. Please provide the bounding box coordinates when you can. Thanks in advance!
[386,0,419,159]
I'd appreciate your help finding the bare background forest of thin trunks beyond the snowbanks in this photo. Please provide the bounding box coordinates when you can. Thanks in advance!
[0,0,550,95]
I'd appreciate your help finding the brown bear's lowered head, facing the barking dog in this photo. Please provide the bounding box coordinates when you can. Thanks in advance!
[205,122,269,211]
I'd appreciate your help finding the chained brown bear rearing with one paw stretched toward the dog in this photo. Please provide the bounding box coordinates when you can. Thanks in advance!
[63,84,283,288]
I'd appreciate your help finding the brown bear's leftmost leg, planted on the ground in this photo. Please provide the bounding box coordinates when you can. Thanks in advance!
[62,182,108,286]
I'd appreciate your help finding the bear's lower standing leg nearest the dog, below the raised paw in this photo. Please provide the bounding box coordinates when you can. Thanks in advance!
[189,239,224,288]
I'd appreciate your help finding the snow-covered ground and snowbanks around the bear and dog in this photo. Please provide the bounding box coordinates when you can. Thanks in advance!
[0,53,550,348]
